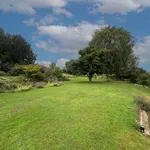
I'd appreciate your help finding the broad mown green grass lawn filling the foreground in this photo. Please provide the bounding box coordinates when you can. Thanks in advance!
[0,78,150,150]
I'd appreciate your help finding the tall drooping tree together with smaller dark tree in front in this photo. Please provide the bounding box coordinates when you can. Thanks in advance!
[66,26,148,81]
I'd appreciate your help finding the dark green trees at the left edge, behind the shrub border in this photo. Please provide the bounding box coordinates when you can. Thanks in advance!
[0,28,36,72]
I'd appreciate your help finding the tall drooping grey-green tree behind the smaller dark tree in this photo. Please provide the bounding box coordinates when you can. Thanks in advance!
[89,26,137,78]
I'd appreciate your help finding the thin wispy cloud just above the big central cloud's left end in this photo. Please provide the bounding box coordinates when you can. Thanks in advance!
[23,15,58,26]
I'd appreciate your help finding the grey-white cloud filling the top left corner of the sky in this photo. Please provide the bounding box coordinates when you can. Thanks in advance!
[0,0,67,15]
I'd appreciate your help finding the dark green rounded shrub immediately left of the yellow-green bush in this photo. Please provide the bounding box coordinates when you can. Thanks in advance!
[11,65,25,76]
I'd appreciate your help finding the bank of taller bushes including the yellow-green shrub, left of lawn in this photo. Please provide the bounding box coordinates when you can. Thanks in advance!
[11,63,67,81]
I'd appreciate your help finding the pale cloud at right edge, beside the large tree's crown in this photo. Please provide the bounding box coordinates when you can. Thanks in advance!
[134,36,150,65]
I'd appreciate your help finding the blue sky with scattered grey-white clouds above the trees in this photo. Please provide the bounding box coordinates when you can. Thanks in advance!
[0,0,150,70]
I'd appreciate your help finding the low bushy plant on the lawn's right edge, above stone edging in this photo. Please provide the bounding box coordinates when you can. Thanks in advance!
[135,96,150,110]
